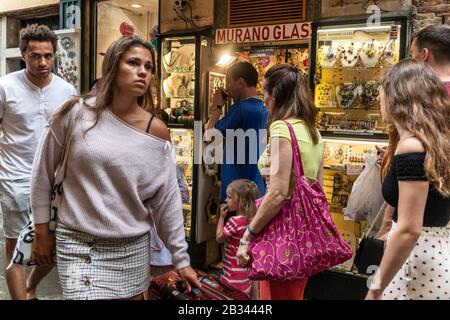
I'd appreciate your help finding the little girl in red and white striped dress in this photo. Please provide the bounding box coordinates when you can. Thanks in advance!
[216,179,259,298]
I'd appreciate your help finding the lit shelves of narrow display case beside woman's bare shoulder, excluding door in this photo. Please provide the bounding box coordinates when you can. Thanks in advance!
[160,35,196,238]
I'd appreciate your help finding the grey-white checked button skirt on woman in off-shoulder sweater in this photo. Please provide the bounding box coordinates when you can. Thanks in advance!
[56,223,150,300]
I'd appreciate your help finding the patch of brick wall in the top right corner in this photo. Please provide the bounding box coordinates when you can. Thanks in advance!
[412,0,450,31]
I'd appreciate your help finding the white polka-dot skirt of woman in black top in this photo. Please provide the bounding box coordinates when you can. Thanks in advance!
[383,224,450,300]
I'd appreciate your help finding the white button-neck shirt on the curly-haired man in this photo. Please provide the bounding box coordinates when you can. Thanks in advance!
[0,70,76,181]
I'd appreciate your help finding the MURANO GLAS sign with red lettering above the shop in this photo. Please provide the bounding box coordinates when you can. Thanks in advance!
[215,22,312,44]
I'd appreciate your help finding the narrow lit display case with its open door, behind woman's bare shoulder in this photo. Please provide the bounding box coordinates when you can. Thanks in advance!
[158,30,222,267]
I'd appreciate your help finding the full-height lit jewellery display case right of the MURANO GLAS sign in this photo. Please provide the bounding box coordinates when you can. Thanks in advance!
[310,17,407,272]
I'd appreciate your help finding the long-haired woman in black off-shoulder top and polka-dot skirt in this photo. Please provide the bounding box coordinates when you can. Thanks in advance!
[366,59,450,300]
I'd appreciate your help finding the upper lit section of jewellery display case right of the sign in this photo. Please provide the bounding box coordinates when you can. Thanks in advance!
[313,21,406,139]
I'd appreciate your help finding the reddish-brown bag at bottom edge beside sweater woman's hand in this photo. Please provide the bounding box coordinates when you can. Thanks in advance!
[149,270,249,300]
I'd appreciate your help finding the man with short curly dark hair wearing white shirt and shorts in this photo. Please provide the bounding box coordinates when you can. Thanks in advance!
[0,24,76,299]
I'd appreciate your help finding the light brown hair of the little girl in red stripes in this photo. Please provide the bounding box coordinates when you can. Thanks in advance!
[227,179,259,223]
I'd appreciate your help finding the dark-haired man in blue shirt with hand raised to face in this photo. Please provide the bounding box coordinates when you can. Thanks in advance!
[205,62,268,203]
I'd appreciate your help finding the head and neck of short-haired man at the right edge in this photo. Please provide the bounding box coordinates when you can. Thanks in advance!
[411,25,450,94]
